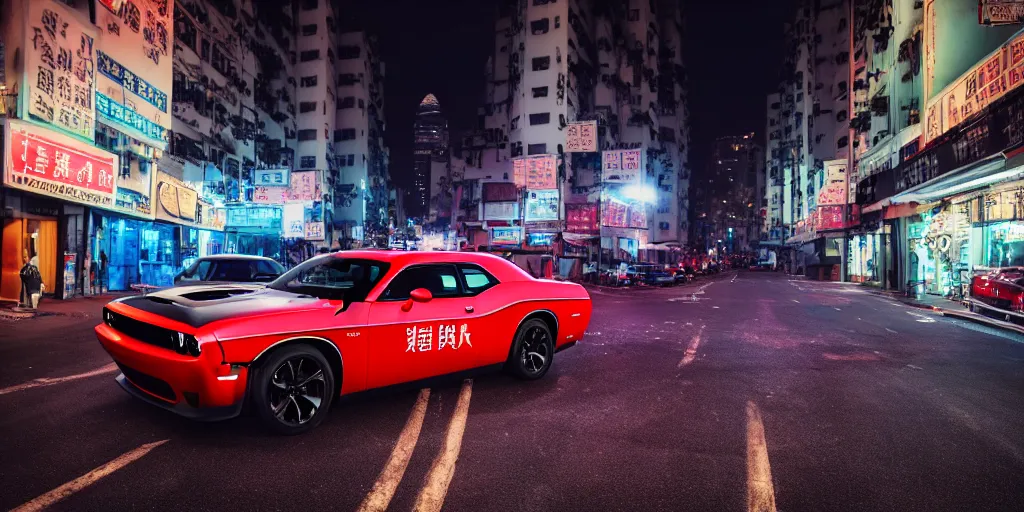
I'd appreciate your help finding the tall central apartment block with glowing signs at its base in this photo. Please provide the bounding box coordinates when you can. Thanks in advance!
[452,0,689,271]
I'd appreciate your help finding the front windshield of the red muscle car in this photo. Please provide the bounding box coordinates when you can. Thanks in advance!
[268,255,388,303]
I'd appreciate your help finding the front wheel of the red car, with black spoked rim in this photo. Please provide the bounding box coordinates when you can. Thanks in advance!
[250,344,335,435]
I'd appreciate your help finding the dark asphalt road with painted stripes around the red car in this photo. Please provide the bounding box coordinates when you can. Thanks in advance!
[0,272,1024,512]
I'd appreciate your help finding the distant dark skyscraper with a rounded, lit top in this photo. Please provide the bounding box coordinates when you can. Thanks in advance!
[407,94,449,216]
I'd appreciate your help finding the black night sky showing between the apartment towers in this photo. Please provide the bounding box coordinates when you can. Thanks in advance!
[343,0,794,186]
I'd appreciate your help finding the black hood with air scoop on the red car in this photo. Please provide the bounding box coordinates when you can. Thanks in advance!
[116,285,319,328]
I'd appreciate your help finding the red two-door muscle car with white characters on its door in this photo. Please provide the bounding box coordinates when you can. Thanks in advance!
[96,251,591,434]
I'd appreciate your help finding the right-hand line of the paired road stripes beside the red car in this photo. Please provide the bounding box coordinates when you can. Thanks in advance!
[413,379,473,512]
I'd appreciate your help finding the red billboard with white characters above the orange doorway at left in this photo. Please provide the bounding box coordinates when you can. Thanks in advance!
[3,119,121,210]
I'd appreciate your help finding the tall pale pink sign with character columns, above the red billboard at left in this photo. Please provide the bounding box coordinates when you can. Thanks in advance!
[24,0,97,141]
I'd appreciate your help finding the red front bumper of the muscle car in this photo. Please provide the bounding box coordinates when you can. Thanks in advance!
[95,324,248,420]
